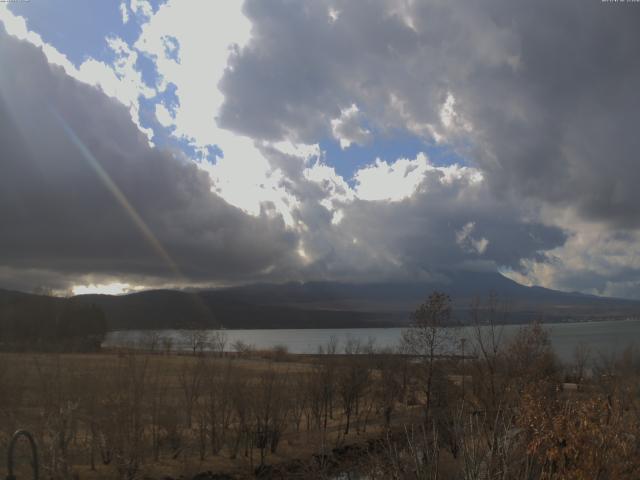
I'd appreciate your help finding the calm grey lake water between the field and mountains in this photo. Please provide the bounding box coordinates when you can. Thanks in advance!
[103,319,640,361]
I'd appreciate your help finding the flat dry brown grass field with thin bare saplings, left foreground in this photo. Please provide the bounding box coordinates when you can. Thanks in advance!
[0,350,424,479]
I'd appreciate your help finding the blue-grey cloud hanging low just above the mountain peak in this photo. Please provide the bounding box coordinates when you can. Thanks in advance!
[320,173,565,275]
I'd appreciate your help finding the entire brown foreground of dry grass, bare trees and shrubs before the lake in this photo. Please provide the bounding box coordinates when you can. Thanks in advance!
[0,292,640,480]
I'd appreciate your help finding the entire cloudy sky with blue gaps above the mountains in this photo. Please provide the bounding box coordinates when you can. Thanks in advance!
[0,0,640,299]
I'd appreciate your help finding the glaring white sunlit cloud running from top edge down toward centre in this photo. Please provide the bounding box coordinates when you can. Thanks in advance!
[135,0,306,226]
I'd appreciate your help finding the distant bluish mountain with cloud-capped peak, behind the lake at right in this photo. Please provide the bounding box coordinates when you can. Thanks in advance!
[199,271,640,323]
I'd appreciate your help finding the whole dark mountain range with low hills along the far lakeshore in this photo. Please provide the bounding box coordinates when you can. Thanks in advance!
[0,272,640,330]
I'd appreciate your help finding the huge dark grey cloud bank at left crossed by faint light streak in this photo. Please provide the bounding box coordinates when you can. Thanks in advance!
[0,31,296,288]
